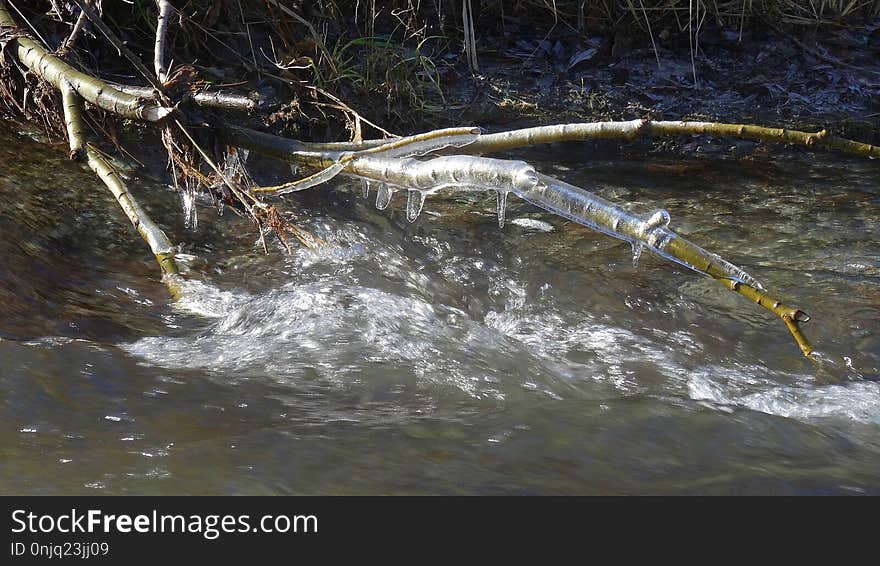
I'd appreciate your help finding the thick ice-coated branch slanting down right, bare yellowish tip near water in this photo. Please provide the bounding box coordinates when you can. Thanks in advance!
[345,151,813,357]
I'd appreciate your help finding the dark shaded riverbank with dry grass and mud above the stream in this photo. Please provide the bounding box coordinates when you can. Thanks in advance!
[3,0,880,151]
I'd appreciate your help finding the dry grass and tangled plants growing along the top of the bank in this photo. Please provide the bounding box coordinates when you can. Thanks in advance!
[11,0,880,132]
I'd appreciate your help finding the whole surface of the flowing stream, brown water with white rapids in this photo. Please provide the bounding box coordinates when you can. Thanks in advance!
[0,125,880,494]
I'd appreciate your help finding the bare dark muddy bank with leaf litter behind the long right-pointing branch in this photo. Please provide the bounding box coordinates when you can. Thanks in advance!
[447,19,880,146]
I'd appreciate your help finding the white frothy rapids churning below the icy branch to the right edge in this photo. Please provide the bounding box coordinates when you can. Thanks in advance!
[124,199,880,423]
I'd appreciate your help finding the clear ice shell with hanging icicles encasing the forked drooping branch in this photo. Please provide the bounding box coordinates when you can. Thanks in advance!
[257,128,763,290]
